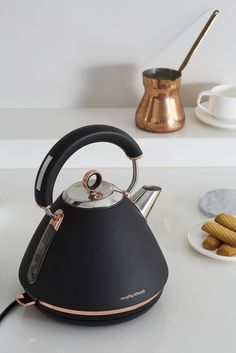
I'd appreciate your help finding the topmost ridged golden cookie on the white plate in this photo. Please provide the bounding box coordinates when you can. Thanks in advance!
[202,221,236,247]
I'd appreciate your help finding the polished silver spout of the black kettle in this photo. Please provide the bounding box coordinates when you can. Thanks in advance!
[130,185,161,218]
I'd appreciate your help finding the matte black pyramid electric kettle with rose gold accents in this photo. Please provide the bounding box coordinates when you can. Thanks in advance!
[16,125,168,323]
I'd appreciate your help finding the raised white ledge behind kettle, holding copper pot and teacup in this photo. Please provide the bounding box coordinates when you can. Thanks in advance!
[0,108,236,168]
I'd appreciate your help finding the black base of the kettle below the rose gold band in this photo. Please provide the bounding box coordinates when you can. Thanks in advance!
[37,290,162,326]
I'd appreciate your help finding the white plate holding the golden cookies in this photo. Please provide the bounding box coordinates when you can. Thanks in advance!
[188,218,236,261]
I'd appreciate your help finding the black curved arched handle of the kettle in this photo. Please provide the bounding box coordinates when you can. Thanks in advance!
[34,125,142,209]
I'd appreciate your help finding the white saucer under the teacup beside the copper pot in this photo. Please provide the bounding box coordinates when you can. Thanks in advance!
[195,102,236,130]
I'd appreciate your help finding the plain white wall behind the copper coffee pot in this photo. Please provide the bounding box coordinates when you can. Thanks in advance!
[0,0,236,108]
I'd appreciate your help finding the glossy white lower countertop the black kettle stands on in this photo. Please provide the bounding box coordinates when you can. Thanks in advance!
[0,168,236,353]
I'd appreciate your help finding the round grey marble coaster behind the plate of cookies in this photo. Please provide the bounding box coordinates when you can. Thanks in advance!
[199,189,236,217]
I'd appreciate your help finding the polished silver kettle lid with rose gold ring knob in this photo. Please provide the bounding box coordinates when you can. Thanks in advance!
[62,170,124,208]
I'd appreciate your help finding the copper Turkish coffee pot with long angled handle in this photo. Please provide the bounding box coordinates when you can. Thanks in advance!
[135,10,219,132]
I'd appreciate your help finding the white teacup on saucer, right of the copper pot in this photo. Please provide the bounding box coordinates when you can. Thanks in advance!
[197,85,236,120]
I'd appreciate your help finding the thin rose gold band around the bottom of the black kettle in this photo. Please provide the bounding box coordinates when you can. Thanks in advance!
[38,291,161,316]
